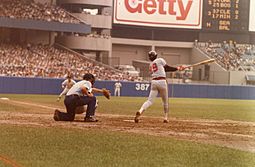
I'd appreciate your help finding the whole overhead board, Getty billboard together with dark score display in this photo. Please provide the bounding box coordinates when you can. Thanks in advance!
[113,0,252,33]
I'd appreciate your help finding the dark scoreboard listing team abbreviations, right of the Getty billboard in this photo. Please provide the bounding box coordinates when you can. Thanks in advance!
[202,0,250,32]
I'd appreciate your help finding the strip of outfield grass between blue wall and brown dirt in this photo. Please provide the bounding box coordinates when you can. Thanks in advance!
[0,94,255,122]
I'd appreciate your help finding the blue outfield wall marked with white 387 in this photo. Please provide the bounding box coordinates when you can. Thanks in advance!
[0,77,255,100]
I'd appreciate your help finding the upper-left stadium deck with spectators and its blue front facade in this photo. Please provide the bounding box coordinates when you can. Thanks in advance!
[0,0,91,34]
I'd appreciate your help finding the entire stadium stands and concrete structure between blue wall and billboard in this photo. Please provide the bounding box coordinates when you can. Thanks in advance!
[0,0,255,85]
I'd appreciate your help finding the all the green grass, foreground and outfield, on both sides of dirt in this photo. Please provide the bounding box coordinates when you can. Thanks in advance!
[0,94,255,167]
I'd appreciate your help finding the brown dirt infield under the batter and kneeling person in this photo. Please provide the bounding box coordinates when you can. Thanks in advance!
[0,101,255,153]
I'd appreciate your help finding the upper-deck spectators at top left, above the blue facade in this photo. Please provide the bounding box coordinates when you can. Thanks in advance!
[0,0,80,24]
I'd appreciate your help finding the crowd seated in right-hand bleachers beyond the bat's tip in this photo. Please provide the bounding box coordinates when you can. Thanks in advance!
[196,41,255,71]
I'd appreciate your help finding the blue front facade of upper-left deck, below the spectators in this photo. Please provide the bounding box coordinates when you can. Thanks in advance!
[0,17,91,34]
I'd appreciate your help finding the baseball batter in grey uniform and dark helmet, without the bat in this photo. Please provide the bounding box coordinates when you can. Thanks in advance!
[135,51,184,123]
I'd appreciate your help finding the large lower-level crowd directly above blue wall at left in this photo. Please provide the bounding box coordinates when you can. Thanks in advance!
[0,43,141,81]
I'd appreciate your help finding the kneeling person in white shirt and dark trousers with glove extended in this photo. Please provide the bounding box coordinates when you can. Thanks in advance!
[53,73,110,122]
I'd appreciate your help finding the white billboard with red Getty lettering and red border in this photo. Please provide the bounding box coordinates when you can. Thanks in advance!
[114,0,203,29]
